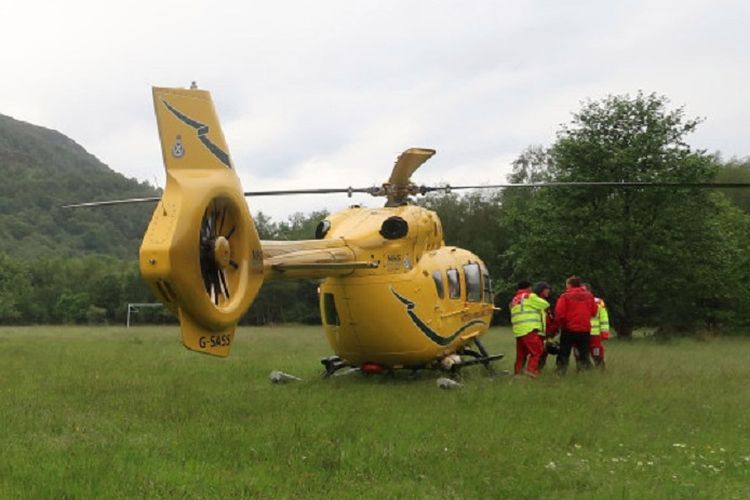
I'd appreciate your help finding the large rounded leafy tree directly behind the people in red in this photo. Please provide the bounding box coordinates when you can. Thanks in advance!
[505,92,747,337]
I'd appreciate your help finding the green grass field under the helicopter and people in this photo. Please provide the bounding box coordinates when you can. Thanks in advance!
[0,327,750,499]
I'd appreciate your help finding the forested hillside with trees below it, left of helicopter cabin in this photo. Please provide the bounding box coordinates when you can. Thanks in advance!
[0,115,325,324]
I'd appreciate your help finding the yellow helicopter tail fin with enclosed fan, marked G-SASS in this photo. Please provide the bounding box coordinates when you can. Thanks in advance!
[140,88,263,356]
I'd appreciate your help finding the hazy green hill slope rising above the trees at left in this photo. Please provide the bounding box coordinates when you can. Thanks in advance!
[0,115,158,259]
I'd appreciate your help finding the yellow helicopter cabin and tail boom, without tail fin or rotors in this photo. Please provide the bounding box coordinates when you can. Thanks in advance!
[262,206,493,367]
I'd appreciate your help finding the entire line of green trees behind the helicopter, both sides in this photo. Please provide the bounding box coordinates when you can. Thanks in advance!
[0,93,750,337]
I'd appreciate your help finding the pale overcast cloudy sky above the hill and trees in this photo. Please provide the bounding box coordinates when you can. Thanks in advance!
[0,0,750,219]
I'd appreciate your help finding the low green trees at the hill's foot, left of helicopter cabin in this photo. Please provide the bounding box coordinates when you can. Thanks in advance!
[0,212,327,325]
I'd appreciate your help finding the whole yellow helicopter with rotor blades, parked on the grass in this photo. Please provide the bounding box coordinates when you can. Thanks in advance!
[68,86,750,375]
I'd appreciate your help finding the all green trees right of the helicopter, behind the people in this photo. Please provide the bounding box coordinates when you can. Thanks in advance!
[426,93,750,337]
